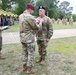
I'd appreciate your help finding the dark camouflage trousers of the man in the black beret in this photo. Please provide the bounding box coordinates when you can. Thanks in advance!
[37,40,48,60]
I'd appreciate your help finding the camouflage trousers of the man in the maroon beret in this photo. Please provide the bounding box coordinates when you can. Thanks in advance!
[22,42,35,67]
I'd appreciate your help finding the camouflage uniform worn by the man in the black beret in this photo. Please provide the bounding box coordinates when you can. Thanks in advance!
[37,16,53,60]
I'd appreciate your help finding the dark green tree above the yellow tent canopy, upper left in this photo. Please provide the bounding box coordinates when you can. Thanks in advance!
[0,0,33,15]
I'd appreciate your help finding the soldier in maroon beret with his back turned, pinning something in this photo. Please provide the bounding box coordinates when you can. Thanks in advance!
[19,3,39,74]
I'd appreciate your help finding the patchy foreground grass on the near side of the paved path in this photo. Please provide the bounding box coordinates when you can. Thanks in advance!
[0,37,76,75]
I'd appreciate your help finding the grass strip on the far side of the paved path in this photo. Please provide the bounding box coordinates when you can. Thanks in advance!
[4,22,76,32]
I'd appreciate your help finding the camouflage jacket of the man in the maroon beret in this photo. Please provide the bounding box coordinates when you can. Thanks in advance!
[20,12,38,43]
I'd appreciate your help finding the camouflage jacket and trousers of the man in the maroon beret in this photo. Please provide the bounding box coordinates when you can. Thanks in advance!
[19,11,38,67]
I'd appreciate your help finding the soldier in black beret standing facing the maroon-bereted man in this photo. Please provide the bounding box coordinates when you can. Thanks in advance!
[36,6,53,64]
